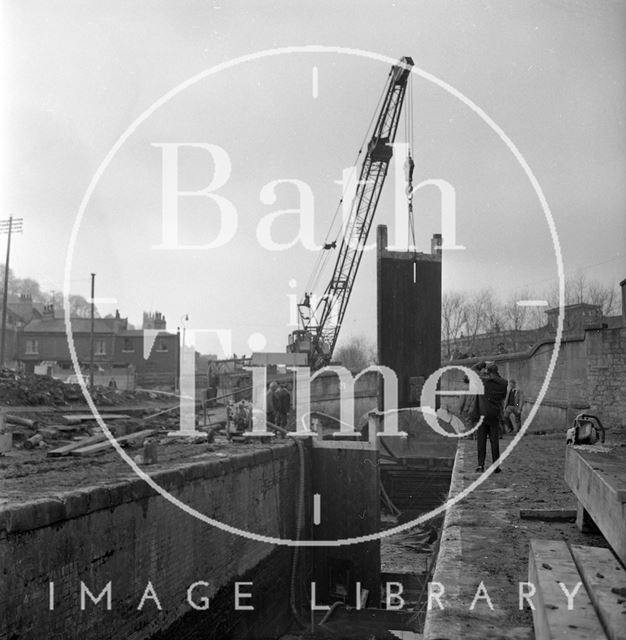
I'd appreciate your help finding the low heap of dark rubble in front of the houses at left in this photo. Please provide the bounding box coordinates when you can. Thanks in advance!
[0,369,149,406]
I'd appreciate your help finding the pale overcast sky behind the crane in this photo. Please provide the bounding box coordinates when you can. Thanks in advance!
[0,0,626,355]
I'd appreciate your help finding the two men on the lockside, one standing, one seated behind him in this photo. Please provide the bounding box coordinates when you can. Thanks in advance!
[466,362,523,473]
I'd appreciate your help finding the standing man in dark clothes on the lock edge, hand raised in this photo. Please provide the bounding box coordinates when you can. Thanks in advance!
[468,364,507,473]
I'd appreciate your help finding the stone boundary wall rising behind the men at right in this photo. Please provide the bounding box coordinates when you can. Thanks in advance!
[441,327,626,431]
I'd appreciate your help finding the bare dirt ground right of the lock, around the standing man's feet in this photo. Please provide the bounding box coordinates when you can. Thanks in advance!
[434,426,626,638]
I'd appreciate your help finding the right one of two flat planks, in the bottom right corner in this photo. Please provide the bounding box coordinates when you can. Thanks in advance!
[572,545,626,640]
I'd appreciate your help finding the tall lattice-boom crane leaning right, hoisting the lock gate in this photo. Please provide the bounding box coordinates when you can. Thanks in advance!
[287,57,413,370]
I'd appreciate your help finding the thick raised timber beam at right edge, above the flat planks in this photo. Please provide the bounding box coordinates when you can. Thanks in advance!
[565,446,626,564]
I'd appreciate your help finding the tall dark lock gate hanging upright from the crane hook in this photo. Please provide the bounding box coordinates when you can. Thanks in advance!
[377,225,441,408]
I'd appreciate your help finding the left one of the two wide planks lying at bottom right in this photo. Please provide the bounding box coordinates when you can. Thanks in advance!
[528,539,607,640]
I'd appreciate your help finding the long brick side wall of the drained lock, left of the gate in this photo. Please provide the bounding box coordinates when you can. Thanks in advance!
[0,443,298,640]
